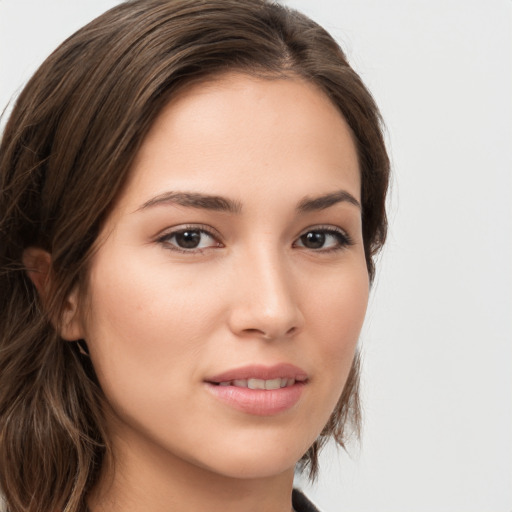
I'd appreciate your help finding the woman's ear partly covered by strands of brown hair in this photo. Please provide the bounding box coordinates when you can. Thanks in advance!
[22,247,84,341]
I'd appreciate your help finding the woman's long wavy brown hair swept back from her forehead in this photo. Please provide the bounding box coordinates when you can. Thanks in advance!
[0,0,389,512]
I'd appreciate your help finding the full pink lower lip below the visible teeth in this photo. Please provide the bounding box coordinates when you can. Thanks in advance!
[206,382,305,416]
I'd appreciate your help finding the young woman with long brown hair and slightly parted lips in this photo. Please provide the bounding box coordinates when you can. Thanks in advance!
[0,0,389,512]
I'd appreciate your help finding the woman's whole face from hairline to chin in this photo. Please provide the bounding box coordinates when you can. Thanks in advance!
[80,74,368,478]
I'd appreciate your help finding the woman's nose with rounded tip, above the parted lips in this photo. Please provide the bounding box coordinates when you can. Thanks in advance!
[229,250,304,340]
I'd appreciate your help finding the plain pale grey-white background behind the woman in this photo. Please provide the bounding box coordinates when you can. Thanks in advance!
[0,0,512,512]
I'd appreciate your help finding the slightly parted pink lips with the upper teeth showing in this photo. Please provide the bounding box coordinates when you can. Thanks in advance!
[205,364,308,416]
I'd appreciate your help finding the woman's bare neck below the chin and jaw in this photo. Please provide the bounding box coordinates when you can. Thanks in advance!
[89,424,294,512]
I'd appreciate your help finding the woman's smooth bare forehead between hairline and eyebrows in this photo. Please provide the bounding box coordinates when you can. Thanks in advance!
[116,73,360,213]
